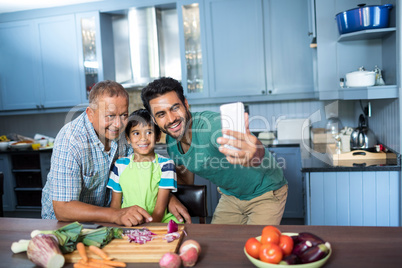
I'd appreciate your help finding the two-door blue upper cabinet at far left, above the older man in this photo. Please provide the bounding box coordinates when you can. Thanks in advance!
[0,15,85,110]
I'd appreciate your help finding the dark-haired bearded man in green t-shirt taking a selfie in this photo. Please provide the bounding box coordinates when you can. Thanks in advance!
[141,78,287,225]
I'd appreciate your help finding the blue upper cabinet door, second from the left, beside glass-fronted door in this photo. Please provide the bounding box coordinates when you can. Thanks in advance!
[37,15,85,108]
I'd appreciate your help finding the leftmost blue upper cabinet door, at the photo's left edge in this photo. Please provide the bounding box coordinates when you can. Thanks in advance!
[0,21,41,110]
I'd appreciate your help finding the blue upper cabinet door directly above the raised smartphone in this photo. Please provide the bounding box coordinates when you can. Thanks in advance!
[205,0,266,97]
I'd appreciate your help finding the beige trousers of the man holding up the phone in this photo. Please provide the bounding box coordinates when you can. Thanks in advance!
[212,185,288,225]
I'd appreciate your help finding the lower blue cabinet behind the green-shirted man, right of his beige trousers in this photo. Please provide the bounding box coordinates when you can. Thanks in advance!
[268,147,304,218]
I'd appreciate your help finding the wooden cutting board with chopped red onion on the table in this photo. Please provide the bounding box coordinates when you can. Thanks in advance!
[64,224,184,263]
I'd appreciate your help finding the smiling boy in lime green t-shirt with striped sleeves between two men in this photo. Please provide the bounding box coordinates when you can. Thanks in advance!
[107,109,179,223]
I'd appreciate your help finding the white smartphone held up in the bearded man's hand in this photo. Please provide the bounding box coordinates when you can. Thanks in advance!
[220,102,246,150]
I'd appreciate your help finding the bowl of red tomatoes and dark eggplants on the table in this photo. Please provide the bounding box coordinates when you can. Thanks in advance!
[244,226,332,268]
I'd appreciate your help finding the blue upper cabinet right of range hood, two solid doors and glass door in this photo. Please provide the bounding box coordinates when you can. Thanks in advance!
[178,0,315,104]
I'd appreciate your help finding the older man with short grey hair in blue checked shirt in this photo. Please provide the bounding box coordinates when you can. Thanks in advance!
[42,81,191,226]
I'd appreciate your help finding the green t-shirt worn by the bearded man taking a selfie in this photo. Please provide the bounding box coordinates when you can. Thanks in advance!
[166,111,287,200]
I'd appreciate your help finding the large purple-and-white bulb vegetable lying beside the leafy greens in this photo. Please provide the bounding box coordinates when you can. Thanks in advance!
[27,234,64,268]
